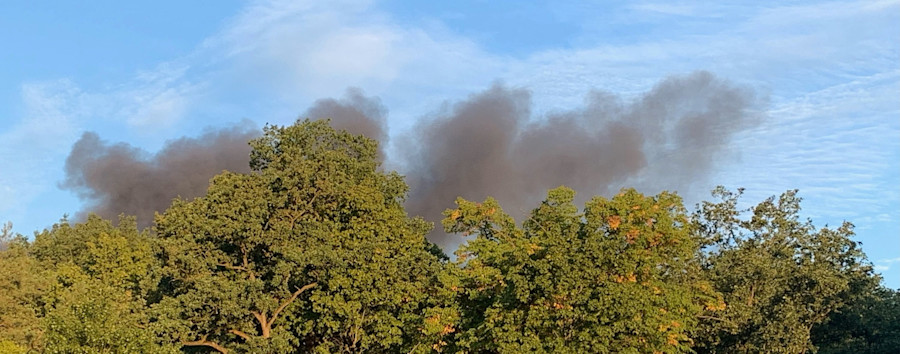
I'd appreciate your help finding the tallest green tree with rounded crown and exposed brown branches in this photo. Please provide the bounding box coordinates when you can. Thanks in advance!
[155,121,449,352]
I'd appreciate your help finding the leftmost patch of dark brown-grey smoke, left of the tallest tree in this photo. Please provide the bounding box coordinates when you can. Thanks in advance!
[60,123,259,227]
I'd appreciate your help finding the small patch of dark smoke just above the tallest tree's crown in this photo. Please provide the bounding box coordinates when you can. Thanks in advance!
[303,87,388,158]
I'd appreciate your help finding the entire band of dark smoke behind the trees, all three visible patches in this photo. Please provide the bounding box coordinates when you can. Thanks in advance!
[63,72,763,249]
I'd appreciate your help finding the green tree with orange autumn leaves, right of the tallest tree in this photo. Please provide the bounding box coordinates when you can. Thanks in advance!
[444,188,714,353]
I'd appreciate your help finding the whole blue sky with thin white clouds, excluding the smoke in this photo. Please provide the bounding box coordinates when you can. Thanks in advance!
[0,0,900,288]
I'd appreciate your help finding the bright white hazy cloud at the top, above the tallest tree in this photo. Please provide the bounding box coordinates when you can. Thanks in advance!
[194,1,497,104]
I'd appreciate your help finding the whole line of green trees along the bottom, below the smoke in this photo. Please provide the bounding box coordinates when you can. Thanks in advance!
[0,121,900,353]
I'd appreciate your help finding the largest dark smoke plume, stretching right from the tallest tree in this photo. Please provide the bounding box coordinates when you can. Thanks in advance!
[403,72,759,249]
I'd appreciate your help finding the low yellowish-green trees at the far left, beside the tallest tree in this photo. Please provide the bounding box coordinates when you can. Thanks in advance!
[0,215,163,353]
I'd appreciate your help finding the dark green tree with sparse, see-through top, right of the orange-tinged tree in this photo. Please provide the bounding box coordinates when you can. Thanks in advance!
[696,187,877,353]
